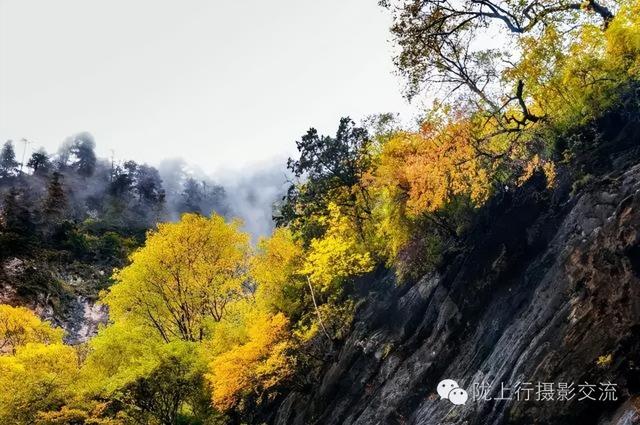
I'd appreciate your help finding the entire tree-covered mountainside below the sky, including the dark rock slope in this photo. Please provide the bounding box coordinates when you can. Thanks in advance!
[0,0,640,425]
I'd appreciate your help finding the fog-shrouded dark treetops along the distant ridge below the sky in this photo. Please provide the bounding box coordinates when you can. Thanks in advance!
[0,132,286,243]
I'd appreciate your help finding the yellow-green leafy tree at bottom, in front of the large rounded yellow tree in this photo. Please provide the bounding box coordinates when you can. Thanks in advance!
[79,312,211,425]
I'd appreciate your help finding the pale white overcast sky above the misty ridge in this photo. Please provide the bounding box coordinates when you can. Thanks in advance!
[0,0,418,172]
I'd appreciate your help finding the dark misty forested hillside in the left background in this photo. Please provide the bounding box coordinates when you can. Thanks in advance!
[0,133,228,341]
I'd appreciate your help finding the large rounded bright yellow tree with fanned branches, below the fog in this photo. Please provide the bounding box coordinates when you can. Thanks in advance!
[104,214,249,342]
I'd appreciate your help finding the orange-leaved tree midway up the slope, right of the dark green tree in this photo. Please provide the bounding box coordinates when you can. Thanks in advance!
[371,114,491,238]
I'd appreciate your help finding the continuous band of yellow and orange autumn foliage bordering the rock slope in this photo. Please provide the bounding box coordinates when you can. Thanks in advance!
[0,0,640,425]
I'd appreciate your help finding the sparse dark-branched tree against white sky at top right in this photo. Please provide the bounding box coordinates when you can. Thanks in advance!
[380,0,618,160]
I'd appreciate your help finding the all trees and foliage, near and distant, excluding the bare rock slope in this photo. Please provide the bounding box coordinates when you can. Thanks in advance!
[0,0,640,425]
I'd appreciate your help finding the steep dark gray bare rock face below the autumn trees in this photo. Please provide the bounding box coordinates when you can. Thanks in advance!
[271,156,640,425]
